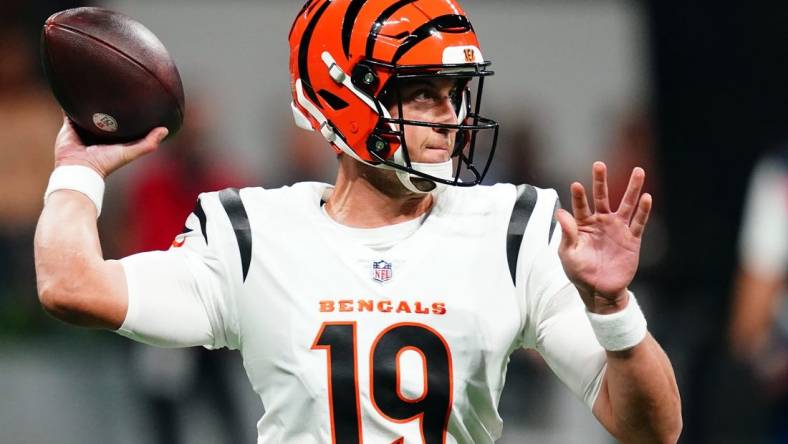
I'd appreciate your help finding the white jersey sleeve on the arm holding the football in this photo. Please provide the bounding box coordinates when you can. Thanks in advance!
[118,193,241,348]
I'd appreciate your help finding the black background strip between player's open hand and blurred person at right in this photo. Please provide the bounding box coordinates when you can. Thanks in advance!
[647,1,788,443]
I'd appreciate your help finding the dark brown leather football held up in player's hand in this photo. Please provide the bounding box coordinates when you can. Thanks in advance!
[41,7,184,144]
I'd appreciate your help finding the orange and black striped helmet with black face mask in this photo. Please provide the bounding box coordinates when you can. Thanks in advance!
[289,0,498,191]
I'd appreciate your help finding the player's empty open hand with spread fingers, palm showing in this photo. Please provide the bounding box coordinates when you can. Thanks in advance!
[556,162,652,314]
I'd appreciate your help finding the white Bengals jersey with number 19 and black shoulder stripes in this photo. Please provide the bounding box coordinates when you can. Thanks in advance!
[119,183,605,444]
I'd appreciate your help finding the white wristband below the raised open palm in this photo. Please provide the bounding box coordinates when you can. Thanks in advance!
[586,293,648,351]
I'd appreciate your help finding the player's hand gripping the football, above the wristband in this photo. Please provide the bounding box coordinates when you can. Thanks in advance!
[55,117,167,178]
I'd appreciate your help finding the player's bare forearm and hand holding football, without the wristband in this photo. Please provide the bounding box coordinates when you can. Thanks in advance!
[34,119,167,329]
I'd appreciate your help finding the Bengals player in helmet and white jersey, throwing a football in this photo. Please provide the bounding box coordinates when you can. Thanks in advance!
[35,0,681,444]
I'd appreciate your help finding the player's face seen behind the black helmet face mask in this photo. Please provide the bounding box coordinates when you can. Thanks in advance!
[389,79,461,163]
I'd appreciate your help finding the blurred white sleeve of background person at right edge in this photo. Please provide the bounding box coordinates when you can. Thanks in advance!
[739,157,788,275]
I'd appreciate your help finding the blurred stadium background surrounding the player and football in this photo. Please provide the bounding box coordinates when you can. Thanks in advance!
[0,0,788,444]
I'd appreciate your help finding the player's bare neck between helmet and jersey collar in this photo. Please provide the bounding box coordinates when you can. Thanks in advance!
[326,156,433,228]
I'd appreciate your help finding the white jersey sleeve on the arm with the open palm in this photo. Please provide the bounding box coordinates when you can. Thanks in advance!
[515,184,607,408]
